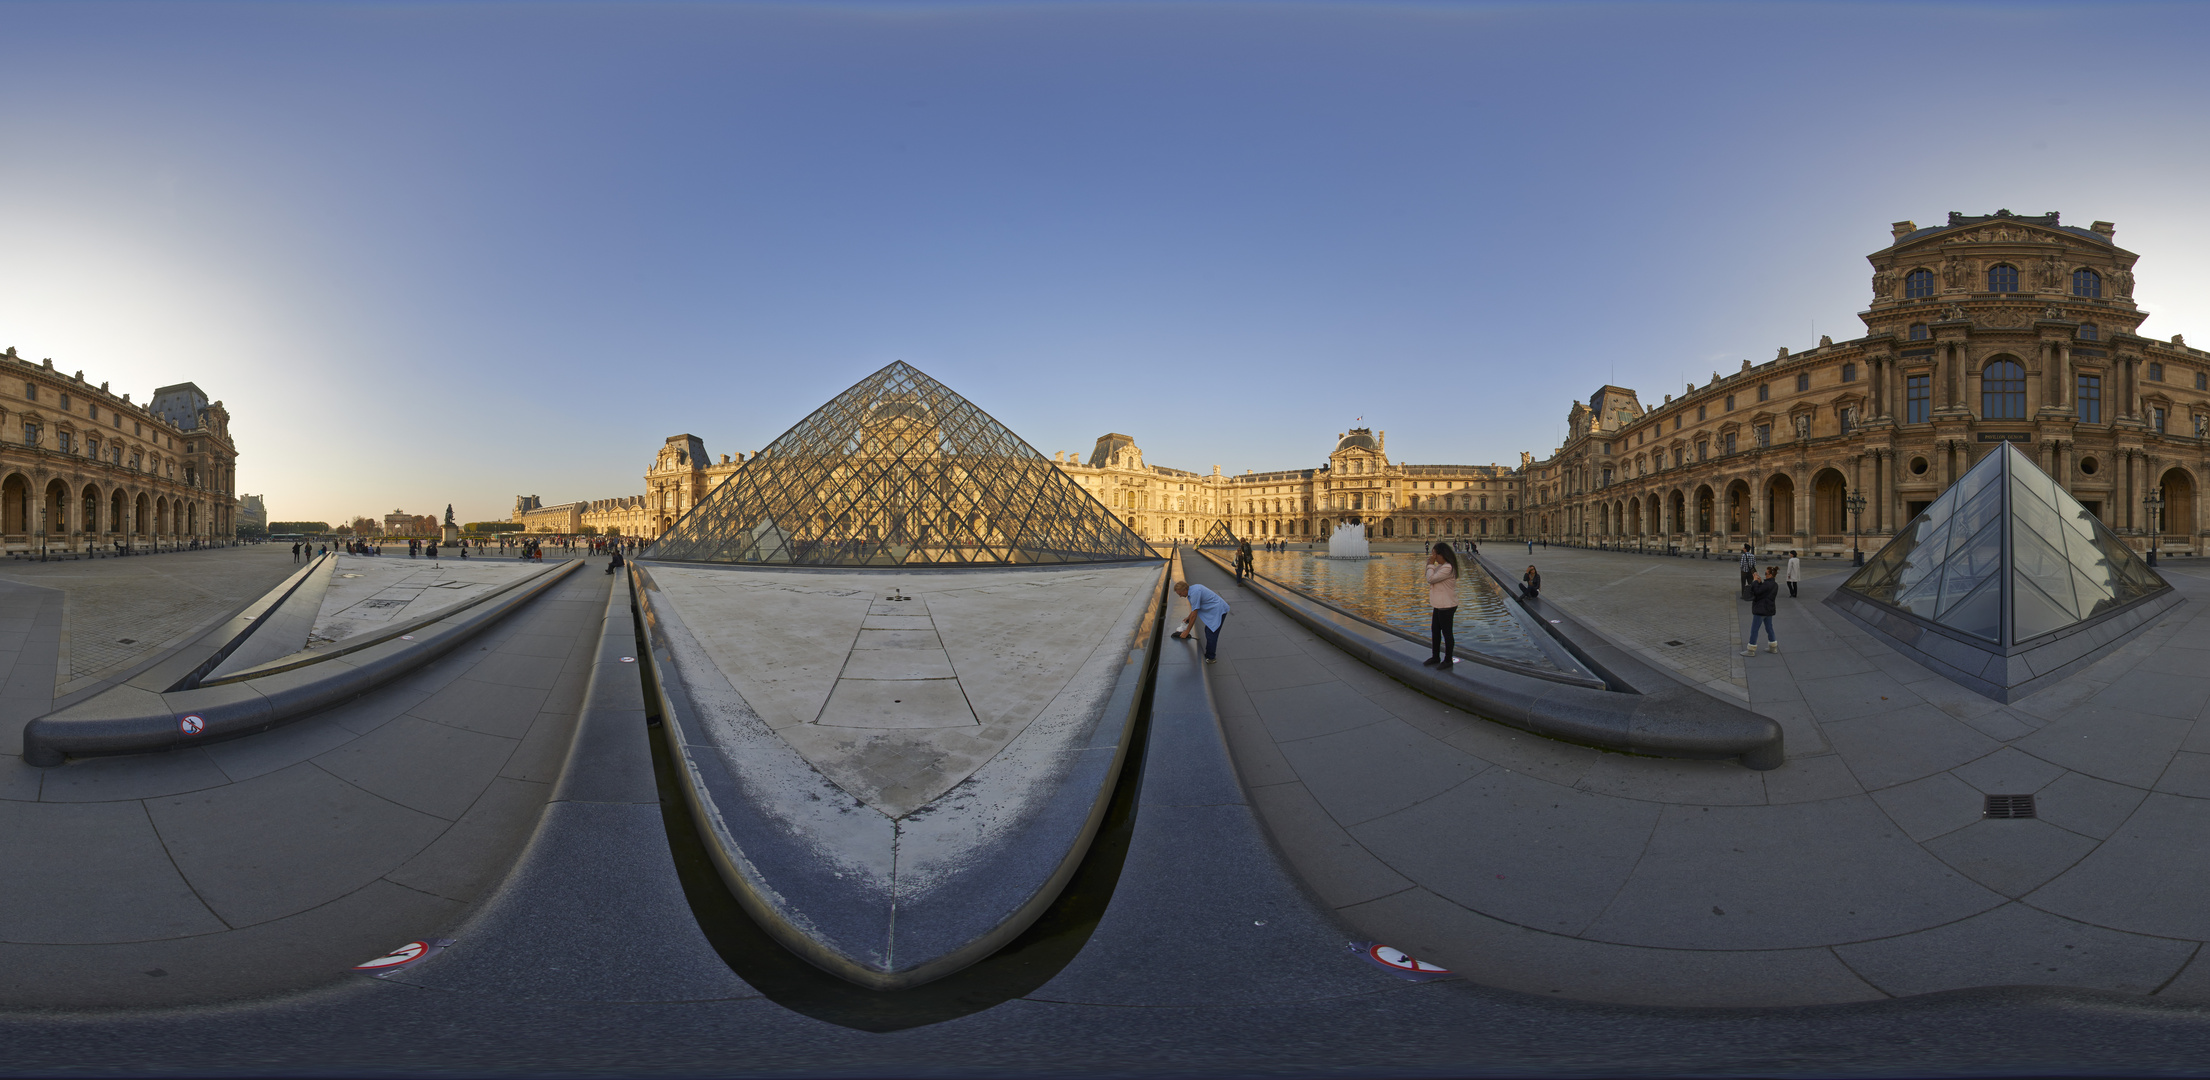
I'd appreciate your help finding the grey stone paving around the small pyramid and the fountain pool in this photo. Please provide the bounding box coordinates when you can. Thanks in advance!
[1189,550,2210,1005]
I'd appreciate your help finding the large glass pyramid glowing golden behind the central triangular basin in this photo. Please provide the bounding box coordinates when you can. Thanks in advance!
[645,360,1158,565]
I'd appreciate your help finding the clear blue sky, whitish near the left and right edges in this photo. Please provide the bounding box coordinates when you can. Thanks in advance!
[0,2,2210,523]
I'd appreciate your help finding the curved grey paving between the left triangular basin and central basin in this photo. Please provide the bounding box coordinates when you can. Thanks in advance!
[0,560,610,1007]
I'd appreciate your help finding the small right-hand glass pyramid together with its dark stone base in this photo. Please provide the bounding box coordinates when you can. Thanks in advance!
[1828,442,2177,700]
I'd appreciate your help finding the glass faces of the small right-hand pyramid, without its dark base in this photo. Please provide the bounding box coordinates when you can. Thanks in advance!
[1841,442,2170,647]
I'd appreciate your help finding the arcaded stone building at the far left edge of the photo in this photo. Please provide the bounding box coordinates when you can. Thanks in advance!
[0,349,239,554]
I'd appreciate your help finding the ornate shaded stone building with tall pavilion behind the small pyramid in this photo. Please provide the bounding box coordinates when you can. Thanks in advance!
[1525,210,2210,552]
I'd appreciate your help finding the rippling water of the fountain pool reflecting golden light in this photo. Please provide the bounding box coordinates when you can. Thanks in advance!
[1246,552,1558,669]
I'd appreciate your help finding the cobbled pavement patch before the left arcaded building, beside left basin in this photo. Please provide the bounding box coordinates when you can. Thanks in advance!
[0,543,298,698]
